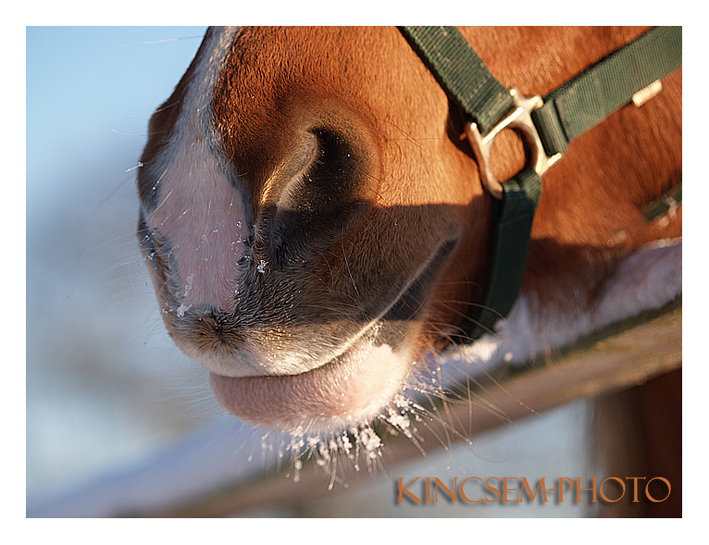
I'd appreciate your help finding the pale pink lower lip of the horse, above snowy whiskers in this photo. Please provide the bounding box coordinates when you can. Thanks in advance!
[209,341,409,431]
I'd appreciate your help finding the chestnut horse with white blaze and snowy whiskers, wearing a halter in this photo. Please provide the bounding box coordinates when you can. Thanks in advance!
[137,27,682,510]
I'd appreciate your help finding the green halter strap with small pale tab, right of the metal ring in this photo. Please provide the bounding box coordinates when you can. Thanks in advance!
[532,27,682,156]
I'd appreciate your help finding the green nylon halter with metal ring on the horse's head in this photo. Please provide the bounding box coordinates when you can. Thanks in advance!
[399,27,682,341]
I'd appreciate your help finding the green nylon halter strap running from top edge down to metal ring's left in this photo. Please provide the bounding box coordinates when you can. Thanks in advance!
[399,27,514,134]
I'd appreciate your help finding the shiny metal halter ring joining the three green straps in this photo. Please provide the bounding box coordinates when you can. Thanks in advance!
[465,89,561,199]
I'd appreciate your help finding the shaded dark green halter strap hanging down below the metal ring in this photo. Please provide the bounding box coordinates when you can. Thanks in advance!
[459,168,542,340]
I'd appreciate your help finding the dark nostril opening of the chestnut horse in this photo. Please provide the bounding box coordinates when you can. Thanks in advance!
[264,127,372,270]
